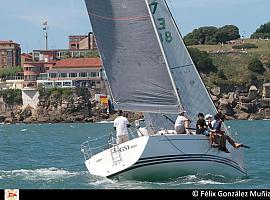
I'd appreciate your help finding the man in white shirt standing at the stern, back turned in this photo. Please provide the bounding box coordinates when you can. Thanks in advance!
[113,110,130,144]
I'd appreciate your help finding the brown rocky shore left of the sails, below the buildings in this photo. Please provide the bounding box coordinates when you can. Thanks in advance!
[0,89,141,123]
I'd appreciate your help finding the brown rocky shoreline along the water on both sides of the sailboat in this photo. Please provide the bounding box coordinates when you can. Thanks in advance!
[0,86,270,123]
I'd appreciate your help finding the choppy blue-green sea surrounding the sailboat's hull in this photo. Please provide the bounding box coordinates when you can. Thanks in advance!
[0,120,270,189]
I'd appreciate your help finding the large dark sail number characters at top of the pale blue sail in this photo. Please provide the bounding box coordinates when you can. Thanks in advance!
[149,0,173,43]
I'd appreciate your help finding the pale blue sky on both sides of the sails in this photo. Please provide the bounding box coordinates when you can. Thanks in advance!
[0,0,270,53]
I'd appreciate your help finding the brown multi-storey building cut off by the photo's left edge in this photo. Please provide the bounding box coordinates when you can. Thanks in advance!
[0,40,21,68]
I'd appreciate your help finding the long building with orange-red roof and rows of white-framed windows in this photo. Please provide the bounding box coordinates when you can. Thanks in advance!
[37,58,101,88]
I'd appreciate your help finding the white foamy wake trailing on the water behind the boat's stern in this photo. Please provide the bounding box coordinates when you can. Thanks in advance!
[0,167,80,180]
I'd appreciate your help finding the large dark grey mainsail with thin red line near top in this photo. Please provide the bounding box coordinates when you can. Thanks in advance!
[85,0,182,113]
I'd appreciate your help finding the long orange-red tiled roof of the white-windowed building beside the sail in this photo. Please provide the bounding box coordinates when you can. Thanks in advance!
[53,58,101,68]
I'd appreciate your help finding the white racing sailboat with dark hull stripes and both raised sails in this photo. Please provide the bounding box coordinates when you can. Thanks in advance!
[81,0,247,180]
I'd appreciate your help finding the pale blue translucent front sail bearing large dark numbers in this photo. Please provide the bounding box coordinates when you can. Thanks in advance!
[148,0,217,125]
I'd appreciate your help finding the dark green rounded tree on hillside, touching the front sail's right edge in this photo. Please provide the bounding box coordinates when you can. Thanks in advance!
[188,48,217,73]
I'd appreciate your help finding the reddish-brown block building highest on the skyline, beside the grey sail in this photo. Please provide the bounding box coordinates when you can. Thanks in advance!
[69,32,97,50]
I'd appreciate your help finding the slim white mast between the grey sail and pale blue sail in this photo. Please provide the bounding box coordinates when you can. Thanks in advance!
[145,0,184,110]
